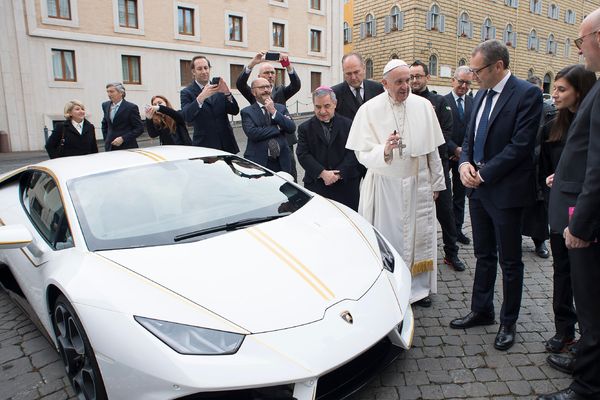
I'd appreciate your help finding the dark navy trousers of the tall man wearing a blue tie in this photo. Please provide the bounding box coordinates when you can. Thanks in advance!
[469,197,523,325]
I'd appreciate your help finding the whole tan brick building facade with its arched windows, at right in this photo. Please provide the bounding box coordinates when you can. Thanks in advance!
[352,0,600,93]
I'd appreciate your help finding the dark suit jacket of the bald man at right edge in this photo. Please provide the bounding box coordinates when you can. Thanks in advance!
[549,81,600,242]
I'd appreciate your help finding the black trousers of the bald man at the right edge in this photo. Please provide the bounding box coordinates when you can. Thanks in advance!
[569,243,600,399]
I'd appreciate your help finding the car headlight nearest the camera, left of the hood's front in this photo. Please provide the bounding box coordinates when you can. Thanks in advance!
[134,316,244,355]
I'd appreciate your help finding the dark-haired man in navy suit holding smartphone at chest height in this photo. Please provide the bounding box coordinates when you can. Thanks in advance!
[180,56,240,154]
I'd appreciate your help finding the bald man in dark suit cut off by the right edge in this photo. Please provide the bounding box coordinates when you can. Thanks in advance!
[539,8,600,400]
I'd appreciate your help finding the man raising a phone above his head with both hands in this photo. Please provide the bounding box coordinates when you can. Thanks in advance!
[236,51,301,181]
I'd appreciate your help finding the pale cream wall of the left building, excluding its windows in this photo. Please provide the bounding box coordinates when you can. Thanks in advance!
[0,0,343,151]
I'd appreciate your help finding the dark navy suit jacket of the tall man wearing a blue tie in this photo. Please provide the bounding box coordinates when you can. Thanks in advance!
[460,75,542,209]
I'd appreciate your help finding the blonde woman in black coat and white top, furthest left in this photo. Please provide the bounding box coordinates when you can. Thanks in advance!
[46,100,98,158]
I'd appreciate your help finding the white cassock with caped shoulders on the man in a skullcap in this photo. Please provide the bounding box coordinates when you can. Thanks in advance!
[346,91,446,303]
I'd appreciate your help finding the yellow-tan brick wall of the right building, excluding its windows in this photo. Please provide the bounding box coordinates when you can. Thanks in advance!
[353,0,600,93]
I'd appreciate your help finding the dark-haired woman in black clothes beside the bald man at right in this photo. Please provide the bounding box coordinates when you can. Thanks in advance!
[540,65,596,353]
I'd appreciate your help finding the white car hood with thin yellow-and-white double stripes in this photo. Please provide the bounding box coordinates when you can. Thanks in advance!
[97,198,381,333]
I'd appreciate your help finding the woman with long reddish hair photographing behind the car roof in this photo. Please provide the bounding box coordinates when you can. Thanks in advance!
[144,95,192,146]
